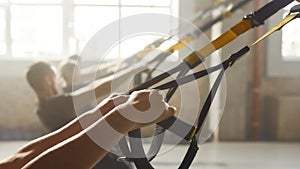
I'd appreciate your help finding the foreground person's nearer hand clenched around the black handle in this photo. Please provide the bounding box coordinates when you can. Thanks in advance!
[107,90,176,133]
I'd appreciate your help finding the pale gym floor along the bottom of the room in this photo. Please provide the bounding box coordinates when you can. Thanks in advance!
[0,141,300,169]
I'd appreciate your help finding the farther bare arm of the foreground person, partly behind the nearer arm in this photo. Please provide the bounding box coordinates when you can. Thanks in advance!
[0,95,128,169]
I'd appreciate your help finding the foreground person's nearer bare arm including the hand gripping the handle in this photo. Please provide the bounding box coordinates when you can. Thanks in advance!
[23,91,175,169]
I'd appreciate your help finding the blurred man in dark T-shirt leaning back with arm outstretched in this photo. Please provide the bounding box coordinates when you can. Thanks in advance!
[26,61,144,168]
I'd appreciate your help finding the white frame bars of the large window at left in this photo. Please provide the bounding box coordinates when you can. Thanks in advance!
[0,0,179,61]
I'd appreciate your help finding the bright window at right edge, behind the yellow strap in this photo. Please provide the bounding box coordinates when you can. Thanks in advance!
[267,2,300,77]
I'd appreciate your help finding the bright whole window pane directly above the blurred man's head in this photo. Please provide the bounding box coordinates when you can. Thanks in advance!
[11,5,63,58]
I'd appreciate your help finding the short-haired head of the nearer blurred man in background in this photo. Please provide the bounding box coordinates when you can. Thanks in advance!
[26,61,62,98]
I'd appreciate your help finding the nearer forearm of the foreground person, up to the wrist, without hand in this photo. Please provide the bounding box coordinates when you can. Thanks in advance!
[24,111,131,169]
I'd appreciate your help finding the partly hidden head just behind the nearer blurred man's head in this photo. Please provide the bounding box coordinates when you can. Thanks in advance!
[60,61,77,86]
